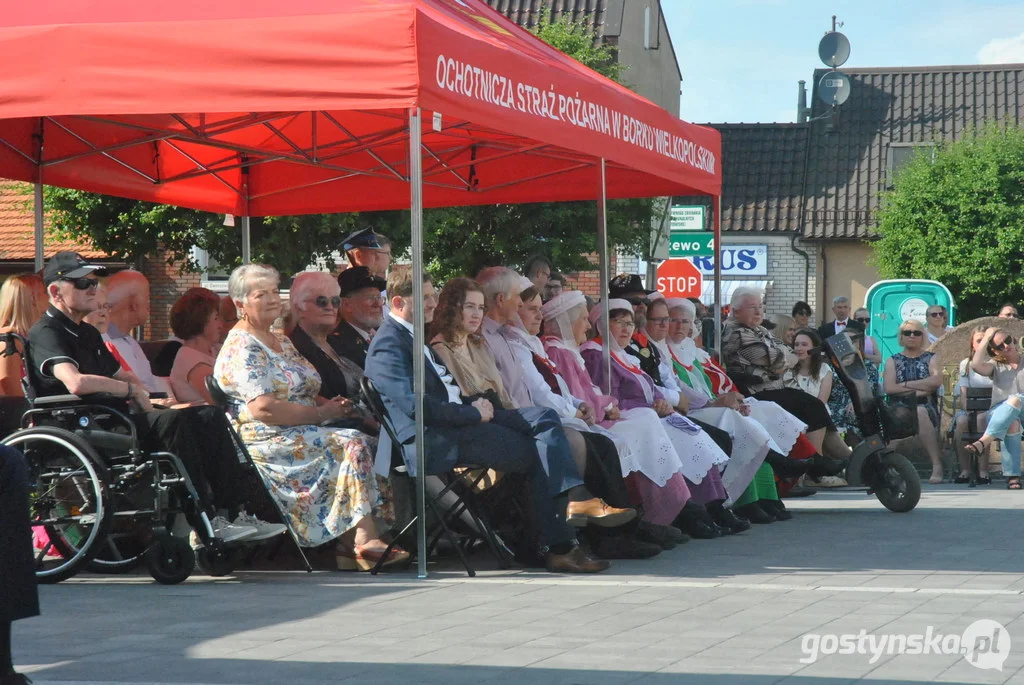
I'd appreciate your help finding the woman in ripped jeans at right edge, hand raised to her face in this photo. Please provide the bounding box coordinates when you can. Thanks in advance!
[967,328,1024,490]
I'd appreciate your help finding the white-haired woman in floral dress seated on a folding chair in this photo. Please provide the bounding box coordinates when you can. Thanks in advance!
[214,264,409,570]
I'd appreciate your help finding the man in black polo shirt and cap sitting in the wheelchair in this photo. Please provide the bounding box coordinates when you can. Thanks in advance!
[27,252,256,542]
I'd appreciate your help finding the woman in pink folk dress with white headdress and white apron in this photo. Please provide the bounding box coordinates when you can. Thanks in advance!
[534,291,690,524]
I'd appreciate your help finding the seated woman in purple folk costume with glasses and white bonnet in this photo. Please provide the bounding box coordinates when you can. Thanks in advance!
[580,299,745,538]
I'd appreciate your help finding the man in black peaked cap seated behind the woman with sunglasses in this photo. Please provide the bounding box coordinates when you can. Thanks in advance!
[331,266,387,369]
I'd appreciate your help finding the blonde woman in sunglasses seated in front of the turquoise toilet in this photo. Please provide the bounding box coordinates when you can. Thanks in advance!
[882,318,942,484]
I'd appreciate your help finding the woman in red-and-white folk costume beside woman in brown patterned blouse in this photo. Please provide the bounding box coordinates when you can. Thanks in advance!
[669,299,817,507]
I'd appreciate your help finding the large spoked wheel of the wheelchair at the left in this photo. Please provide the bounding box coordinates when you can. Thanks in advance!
[2,426,114,583]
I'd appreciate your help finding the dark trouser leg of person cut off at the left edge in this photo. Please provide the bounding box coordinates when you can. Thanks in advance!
[0,446,39,622]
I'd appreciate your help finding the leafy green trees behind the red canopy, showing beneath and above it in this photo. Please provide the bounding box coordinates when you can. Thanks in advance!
[45,12,652,279]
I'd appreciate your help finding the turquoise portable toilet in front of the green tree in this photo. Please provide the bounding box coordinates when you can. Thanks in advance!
[864,279,956,363]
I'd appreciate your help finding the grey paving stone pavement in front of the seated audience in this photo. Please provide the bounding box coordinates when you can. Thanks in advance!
[14,485,1024,685]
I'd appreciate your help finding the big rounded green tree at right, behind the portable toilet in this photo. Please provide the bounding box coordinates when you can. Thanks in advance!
[873,125,1024,320]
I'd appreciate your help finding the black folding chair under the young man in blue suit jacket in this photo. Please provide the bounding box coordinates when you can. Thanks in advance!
[359,376,513,577]
